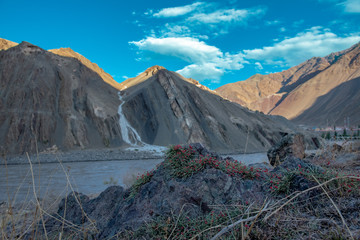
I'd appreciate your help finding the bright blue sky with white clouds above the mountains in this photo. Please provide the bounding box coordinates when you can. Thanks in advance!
[0,0,360,89]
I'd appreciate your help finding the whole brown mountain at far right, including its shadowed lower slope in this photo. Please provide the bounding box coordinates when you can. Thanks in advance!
[216,43,360,125]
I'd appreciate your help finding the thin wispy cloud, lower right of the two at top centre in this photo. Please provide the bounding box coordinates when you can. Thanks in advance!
[187,8,265,24]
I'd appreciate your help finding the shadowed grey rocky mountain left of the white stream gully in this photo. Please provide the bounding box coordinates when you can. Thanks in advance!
[0,42,123,153]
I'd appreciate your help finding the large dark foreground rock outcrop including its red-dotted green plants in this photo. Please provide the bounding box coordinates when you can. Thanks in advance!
[37,145,360,239]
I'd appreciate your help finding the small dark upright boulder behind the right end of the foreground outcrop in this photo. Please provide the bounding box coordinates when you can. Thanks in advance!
[267,133,305,166]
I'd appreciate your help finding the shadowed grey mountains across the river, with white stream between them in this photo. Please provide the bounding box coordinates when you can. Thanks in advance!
[0,37,299,154]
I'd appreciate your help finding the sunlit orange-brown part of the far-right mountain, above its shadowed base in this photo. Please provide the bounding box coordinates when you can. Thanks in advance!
[216,43,360,125]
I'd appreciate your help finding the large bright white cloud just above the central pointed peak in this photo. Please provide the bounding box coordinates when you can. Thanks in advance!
[130,37,246,81]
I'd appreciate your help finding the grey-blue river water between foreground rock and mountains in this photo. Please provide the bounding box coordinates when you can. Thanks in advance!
[0,153,267,203]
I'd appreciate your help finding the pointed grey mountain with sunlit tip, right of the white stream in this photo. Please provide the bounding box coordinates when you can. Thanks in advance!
[122,66,306,152]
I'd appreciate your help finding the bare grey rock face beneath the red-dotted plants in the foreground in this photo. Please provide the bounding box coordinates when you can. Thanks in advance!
[46,144,270,239]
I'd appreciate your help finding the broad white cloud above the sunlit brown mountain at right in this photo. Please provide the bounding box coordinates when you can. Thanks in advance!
[243,26,360,66]
